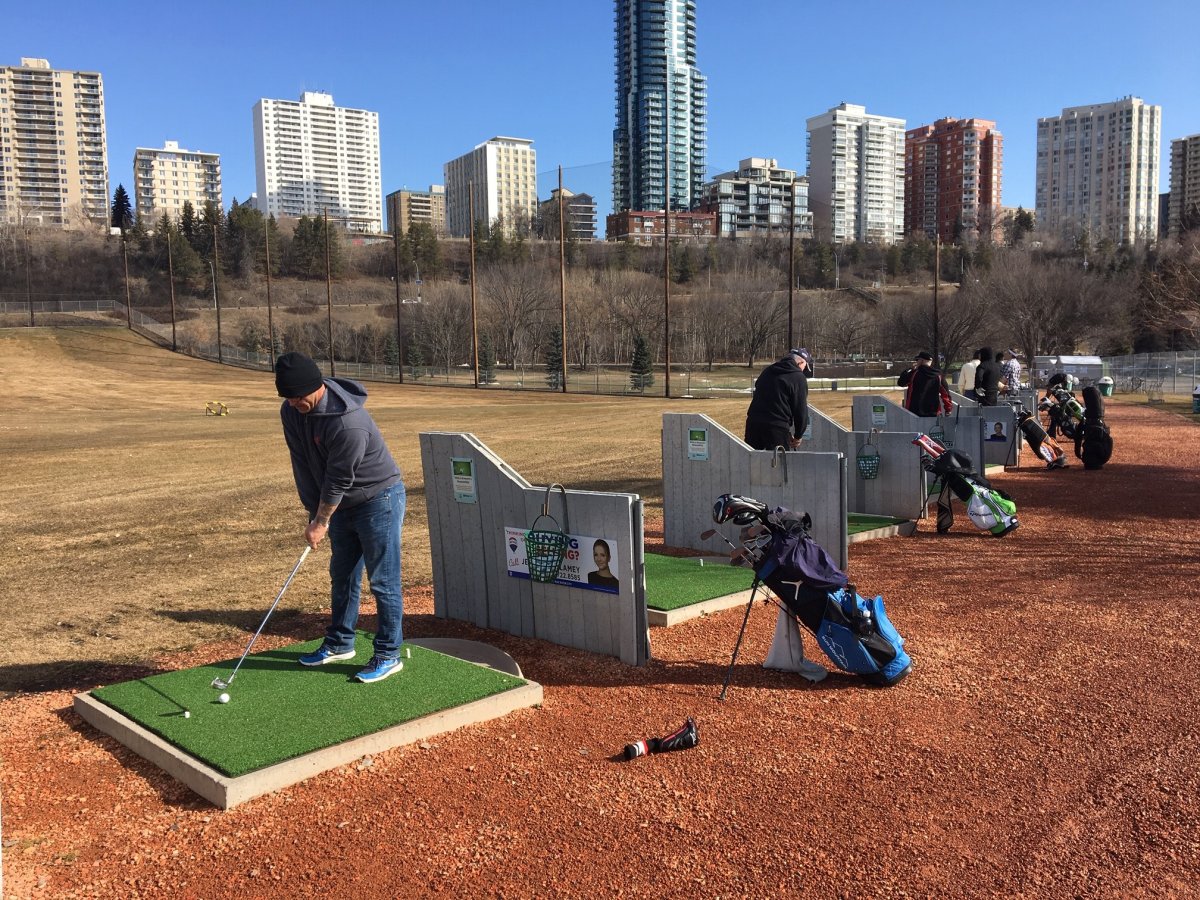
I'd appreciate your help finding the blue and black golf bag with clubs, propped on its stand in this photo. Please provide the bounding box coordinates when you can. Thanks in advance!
[713,494,912,686]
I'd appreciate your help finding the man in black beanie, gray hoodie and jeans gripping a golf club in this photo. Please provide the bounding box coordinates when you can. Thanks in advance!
[275,353,406,684]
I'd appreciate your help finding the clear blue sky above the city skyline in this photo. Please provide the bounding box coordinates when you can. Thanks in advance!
[0,0,1200,220]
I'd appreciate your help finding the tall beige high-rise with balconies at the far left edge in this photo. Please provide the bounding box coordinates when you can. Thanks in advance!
[0,58,109,228]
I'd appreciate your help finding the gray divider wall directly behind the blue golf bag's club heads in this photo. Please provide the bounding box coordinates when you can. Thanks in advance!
[662,413,848,568]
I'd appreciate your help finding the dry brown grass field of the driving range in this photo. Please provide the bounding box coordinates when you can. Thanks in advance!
[0,326,864,695]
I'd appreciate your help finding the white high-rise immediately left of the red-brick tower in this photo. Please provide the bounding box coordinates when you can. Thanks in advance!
[808,103,905,244]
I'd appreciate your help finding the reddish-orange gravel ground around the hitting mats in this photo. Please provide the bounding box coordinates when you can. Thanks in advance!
[0,406,1200,899]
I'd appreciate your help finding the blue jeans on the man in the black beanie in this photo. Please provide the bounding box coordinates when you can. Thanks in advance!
[325,484,406,659]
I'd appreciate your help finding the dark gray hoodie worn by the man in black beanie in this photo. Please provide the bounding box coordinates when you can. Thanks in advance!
[280,378,401,516]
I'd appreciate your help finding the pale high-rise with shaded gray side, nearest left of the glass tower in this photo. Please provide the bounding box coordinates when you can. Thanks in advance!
[443,137,538,238]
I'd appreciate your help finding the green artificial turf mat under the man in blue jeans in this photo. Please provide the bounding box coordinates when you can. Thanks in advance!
[91,632,526,776]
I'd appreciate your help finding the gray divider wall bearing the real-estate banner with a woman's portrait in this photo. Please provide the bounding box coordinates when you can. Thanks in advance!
[420,432,650,666]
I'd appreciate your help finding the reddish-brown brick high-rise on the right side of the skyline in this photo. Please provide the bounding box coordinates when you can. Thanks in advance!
[904,119,1004,240]
